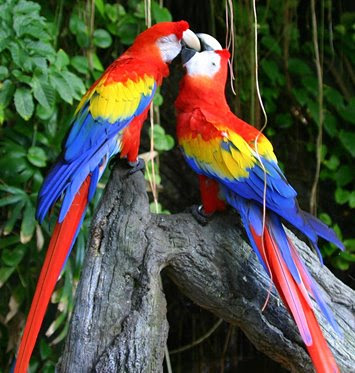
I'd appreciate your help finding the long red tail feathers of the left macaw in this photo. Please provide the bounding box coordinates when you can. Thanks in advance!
[15,176,90,373]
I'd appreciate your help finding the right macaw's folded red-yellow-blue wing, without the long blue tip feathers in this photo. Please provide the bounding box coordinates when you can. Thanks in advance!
[179,109,296,211]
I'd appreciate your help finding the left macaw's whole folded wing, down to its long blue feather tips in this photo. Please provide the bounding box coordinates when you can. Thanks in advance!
[37,63,156,222]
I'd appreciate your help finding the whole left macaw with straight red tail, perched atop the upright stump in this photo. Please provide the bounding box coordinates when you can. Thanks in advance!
[15,21,199,373]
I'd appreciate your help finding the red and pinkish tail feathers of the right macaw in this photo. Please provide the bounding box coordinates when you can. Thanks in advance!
[250,222,339,373]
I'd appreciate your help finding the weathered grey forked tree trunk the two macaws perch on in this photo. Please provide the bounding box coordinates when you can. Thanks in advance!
[57,166,355,373]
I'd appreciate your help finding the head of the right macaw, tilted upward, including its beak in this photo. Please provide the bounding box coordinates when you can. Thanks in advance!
[181,34,230,87]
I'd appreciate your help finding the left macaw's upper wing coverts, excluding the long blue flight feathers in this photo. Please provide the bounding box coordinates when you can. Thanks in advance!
[64,61,156,162]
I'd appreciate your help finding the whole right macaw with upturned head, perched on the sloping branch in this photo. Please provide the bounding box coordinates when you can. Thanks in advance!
[175,34,344,373]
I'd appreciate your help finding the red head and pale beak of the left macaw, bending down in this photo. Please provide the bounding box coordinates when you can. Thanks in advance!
[127,21,201,63]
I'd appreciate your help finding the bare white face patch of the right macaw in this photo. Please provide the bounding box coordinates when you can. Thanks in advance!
[185,51,221,78]
